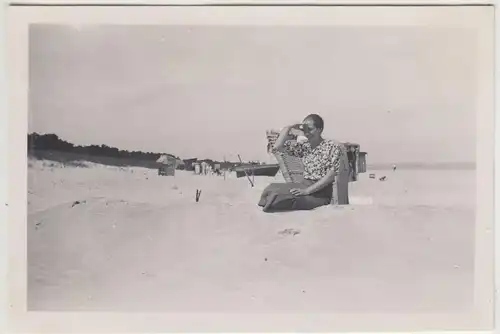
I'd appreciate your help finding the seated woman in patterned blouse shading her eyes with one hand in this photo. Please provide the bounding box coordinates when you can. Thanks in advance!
[259,114,347,212]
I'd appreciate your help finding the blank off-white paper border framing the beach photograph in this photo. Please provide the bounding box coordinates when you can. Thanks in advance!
[7,6,495,333]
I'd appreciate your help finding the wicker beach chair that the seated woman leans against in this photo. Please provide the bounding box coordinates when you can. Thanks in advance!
[266,130,349,205]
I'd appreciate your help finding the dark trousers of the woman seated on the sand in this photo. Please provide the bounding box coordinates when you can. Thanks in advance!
[258,180,332,212]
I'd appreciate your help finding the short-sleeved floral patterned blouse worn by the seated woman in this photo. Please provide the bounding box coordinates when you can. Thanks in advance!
[278,139,346,181]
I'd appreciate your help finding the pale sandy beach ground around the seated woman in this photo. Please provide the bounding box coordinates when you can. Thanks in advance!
[27,161,475,313]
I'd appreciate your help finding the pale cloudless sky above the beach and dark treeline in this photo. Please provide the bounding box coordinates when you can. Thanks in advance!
[29,25,477,163]
